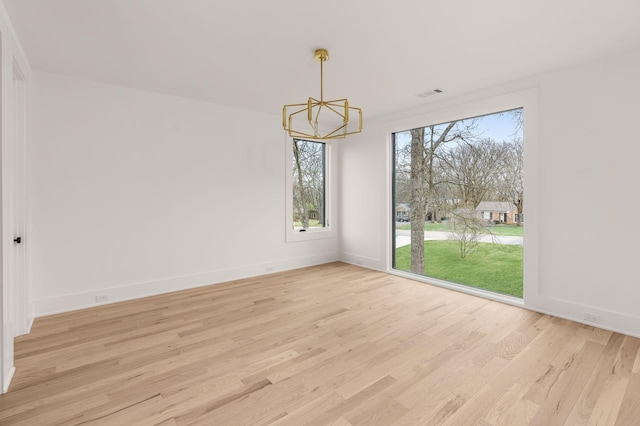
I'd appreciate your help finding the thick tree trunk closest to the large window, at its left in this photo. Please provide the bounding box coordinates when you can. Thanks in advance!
[410,128,426,275]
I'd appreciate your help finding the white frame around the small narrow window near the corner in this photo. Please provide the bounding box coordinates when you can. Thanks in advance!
[285,135,337,243]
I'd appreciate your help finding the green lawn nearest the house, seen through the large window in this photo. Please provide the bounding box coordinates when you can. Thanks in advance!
[395,241,523,297]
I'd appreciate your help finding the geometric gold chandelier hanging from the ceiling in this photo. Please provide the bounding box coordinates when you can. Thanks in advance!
[282,49,362,139]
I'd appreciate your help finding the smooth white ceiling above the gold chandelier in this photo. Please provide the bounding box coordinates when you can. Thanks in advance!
[2,0,640,119]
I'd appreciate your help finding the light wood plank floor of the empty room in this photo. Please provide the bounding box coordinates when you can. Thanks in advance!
[0,263,640,426]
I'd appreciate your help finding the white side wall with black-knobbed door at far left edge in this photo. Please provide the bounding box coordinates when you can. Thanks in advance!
[0,12,33,393]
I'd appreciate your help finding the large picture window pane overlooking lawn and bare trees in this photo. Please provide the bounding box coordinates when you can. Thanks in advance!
[392,108,525,298]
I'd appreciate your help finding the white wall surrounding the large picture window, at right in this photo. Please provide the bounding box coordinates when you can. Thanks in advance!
[340,51,640,336]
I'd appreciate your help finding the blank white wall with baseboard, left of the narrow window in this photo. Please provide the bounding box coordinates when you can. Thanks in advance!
[31,72,338,315]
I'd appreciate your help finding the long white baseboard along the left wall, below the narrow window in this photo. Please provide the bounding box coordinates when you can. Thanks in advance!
[33,252,338,318]
